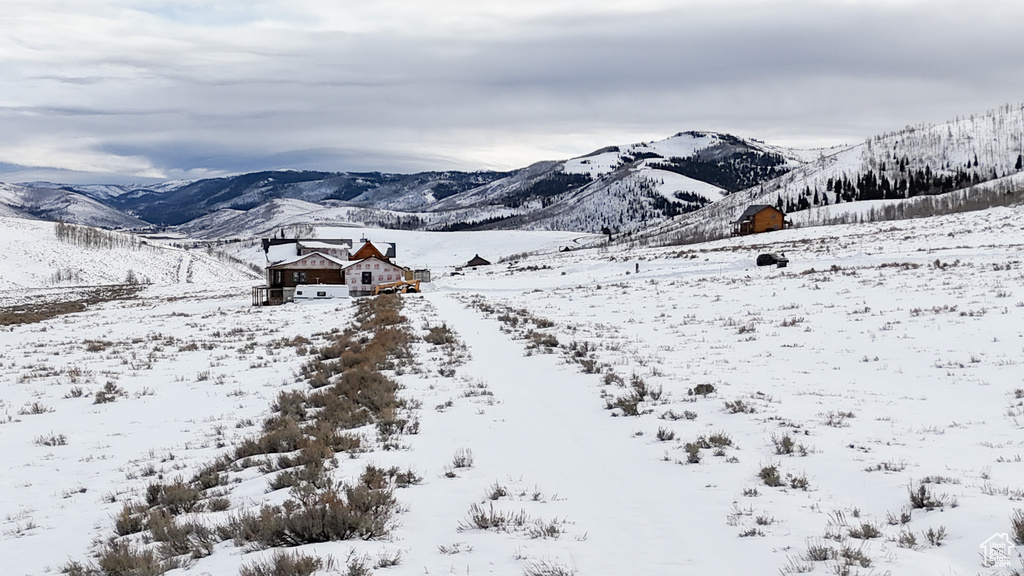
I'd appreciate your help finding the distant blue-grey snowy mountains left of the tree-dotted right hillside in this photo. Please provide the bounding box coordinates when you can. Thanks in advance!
[0,132,803,238]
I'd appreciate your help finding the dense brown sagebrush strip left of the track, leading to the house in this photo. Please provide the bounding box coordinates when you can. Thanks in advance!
[63,296,411,576]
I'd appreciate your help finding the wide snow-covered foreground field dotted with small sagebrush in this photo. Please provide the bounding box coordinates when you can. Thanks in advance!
[0,208,1024,576]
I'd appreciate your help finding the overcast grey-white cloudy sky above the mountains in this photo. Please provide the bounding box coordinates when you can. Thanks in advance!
[0,0,1024,182]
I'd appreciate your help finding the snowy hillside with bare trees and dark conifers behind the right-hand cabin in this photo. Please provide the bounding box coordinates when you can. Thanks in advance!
[643,104,1024,243]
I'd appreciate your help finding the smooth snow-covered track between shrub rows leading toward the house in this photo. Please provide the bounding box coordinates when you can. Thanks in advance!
[402,292,770,574]
